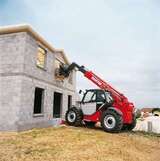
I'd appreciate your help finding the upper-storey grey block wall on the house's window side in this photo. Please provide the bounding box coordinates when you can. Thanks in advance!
[23,33,76,91]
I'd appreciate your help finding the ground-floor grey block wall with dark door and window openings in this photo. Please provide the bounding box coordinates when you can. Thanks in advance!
[18,76,75,131]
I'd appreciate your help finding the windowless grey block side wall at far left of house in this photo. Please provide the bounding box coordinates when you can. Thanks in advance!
[0,33,25,131]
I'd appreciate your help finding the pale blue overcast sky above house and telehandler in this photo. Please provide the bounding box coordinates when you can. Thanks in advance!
[0,0,160,107]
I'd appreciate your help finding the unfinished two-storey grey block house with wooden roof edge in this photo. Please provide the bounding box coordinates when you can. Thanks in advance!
[0,25,76,131]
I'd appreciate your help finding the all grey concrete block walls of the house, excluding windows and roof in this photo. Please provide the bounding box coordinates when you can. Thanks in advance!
[0,28,76,131]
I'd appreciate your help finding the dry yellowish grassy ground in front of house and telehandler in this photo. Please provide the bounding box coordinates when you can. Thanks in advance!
[0,126,160,161]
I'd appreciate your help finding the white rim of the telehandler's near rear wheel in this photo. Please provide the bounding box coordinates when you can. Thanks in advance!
[104,115,116,129]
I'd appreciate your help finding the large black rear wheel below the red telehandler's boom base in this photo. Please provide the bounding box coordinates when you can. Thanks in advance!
[101,110,123,133]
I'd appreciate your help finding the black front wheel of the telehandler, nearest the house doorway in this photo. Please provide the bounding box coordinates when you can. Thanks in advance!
[65,107,83,126]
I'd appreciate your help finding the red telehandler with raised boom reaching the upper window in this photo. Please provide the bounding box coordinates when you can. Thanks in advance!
[58,63,136,132]
